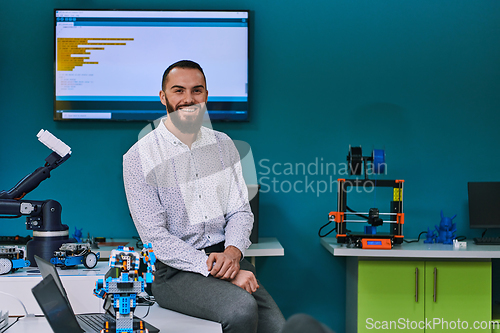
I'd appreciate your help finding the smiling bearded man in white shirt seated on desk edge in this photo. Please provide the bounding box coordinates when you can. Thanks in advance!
[123,60,285,333]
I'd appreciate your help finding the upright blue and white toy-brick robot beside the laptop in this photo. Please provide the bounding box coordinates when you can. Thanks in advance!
[94,244,156,333]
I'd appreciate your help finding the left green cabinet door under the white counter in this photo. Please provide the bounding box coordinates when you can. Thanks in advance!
[357,260,425,332]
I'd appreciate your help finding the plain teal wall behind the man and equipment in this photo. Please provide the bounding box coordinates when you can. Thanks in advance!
[0,0,500,332]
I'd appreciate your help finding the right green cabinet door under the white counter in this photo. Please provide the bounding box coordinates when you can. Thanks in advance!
[425,261,492,332]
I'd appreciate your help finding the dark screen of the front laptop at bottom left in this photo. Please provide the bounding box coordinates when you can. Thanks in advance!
[32,275,83,333]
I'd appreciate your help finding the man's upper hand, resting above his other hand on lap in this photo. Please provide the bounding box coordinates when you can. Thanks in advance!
[207,246,241,280]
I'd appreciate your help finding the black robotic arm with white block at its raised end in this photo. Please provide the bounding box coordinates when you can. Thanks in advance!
[0,129,74,265]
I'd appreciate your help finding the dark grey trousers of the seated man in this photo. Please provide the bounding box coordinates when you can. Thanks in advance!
[152,259,285,333]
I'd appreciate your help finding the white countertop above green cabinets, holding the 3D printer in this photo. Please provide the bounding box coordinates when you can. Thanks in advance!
[320,237,500,259]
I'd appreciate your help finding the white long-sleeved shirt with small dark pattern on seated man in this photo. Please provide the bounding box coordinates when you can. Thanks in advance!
[123,121,253,276]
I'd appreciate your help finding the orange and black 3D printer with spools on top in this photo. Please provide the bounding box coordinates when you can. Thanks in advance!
[329,147,404,249]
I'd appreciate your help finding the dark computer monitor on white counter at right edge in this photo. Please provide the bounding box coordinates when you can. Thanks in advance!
[468,182,500,229]
